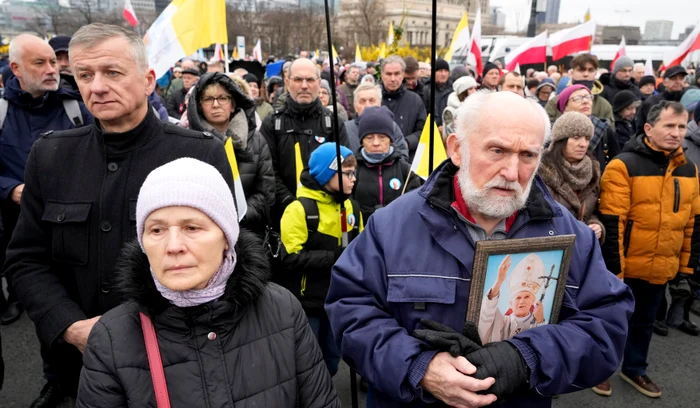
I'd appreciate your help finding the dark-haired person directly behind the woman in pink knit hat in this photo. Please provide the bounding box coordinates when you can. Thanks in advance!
[545,54,615,126]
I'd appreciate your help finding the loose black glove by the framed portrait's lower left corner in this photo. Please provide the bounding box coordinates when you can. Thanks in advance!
[413,319,481,357]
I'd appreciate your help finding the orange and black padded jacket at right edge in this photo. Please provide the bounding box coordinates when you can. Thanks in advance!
[600,135,700,285]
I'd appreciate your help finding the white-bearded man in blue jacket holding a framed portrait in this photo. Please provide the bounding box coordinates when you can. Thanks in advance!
[326,92,634,408]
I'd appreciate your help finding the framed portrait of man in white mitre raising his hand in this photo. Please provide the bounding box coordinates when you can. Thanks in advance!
[467,235,576,344]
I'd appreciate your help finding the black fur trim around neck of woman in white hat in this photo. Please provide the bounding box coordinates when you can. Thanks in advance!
[116,229,270,317]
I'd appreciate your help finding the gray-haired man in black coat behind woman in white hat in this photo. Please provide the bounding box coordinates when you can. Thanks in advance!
[6,24,233,406]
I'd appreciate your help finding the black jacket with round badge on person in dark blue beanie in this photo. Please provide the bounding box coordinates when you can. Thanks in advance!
[353,150,423,225]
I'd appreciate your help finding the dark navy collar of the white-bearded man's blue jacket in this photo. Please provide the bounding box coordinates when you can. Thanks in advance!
[419,159,562,223]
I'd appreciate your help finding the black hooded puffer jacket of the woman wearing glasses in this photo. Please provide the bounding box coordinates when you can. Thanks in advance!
[187,72,275,234]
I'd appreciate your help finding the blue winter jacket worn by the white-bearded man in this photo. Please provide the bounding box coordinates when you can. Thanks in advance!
[326,160,634,408]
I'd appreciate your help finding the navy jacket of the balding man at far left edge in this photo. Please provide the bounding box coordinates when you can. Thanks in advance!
[0,77,92,200]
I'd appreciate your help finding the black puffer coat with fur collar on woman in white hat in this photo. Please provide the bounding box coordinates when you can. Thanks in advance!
[77,230,340,408]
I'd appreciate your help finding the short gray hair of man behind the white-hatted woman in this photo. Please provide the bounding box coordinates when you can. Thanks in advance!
[68,23,148,71]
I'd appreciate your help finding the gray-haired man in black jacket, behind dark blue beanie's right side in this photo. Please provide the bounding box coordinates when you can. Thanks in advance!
[382,55,428,160]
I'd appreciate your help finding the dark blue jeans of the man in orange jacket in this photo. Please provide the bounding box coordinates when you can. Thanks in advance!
[622,278,666,376]
